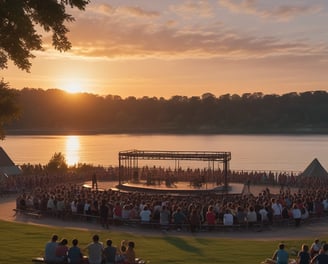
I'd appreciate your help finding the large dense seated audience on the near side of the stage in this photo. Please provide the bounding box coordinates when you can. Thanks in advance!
[16,175,328,232]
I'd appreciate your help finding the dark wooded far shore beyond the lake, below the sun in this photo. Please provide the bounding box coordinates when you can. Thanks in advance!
[6,88,328,134]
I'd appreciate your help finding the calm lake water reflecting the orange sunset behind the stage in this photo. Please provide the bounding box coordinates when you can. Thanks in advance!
[0,134,328,172]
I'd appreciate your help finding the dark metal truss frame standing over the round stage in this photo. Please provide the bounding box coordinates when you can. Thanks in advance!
[119,149,231,186]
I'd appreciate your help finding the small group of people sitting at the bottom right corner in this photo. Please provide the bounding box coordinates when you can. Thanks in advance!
[263,239,328,264]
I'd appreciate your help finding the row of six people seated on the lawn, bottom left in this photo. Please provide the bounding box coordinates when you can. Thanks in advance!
[44,234,140,264]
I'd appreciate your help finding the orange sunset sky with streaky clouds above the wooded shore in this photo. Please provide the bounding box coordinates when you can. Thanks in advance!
[0,0,328,98]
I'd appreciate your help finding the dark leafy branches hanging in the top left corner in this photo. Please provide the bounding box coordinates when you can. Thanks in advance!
[0,0,89,71]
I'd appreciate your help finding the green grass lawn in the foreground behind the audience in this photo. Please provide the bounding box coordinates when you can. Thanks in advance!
[0,221,313,264]
